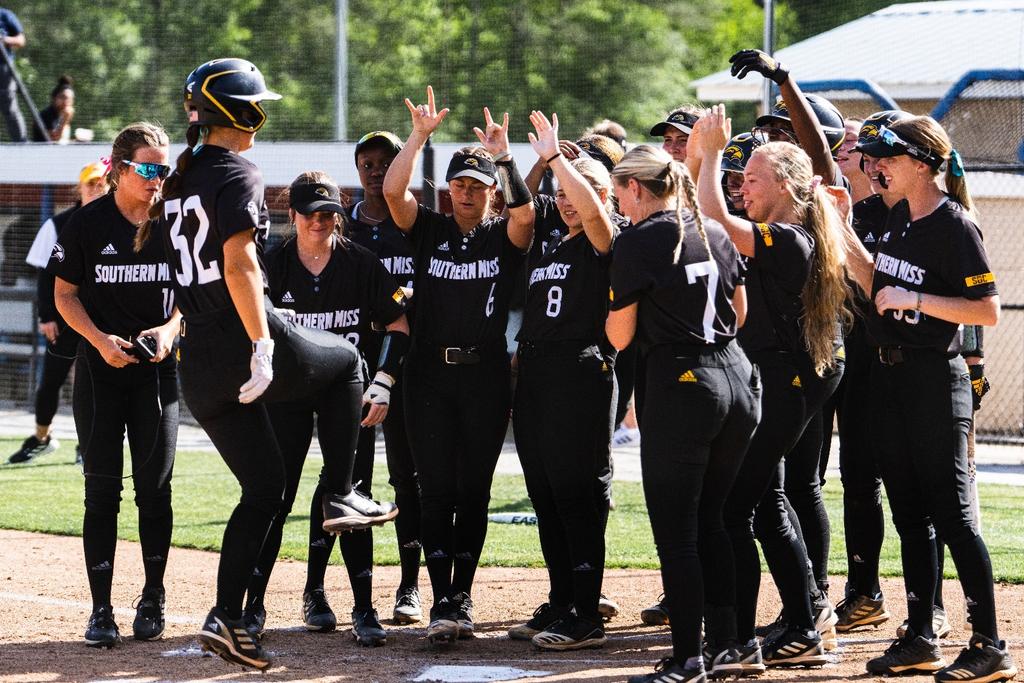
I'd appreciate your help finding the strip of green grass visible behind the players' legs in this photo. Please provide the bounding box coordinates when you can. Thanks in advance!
[0,439,1024,584]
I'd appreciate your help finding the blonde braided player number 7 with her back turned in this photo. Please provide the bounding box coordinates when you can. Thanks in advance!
[606,144,760,683]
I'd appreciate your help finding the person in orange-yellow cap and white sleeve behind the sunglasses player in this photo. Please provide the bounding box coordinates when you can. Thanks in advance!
[7,158,111,464]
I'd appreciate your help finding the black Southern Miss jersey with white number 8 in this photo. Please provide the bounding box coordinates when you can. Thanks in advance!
[517,227,617,344]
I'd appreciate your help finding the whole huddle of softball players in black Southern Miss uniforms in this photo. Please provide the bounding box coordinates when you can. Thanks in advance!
[22,50,1017,683]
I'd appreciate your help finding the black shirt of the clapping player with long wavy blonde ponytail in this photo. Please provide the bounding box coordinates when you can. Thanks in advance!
[738,223,814,353]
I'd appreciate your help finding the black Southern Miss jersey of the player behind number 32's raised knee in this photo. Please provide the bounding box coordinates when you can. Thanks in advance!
[267,238,406,352]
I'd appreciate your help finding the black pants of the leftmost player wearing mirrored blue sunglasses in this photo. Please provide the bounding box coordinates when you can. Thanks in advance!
[73,341,178,607]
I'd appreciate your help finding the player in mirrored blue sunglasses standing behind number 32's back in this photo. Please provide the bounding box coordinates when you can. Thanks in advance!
[50,123,181,647]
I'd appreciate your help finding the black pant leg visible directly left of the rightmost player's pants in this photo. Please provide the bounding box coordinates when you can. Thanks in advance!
[838,324,885,597]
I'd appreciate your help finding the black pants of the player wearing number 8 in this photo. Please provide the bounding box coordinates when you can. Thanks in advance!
[512,344,614,624]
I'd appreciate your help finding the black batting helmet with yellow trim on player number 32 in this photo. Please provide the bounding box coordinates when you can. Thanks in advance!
[184,57,281,133]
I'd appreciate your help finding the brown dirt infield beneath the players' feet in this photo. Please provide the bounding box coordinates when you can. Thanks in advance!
[0,530,1024,683]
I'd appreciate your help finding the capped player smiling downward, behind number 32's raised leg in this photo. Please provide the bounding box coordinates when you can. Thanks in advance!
[239,171,409,645]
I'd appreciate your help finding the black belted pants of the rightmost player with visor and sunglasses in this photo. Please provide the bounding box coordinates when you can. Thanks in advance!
[871,351,998,641]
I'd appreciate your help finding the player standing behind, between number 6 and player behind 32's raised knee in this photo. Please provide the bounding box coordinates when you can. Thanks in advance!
[344,130,423,624]
